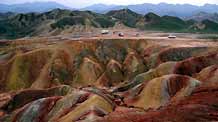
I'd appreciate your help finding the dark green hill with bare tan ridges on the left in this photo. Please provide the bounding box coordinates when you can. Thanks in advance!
[0,9,115,38]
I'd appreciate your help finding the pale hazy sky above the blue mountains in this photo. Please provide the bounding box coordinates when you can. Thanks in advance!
[0,0,218,8]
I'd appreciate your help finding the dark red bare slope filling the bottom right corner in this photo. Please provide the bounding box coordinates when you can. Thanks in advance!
[98,86,218,122]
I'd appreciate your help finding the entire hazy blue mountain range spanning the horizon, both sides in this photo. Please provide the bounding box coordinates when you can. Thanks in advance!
[0,2,218,19]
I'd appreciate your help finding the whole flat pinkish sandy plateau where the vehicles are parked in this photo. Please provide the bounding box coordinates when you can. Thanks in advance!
[0,27,218,47]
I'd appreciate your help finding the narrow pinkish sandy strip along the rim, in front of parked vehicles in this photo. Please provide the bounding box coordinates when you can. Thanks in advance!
[5,36,218,50]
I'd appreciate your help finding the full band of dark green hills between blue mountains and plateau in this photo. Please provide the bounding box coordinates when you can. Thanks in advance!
[0,9,218,38]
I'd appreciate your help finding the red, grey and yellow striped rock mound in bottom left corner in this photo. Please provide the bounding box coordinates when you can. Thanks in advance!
[0,86,115,122]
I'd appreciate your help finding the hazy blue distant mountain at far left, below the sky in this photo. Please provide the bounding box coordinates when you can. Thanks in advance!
[0,2,71,13]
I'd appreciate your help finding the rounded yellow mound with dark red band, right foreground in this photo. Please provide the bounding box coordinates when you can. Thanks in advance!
[125,75,201,109]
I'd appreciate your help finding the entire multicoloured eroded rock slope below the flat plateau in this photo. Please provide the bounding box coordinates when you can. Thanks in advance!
[0,38,218,122]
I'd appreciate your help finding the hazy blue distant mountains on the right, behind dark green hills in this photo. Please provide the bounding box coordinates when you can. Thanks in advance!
[81,3,218,18]
